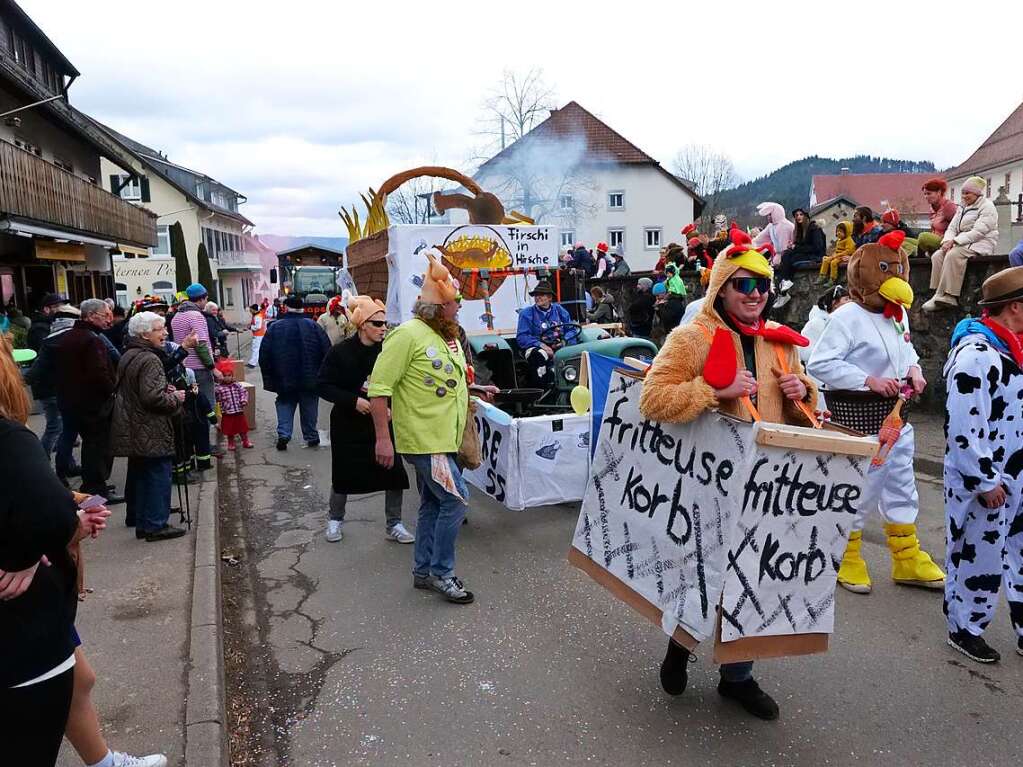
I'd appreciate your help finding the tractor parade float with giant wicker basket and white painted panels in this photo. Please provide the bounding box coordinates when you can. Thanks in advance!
[341,167,657,510]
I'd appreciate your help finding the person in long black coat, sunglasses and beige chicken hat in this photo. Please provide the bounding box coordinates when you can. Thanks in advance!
[319,296,415,543]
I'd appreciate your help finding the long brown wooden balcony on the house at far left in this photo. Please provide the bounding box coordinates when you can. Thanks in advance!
[0,141,157,247]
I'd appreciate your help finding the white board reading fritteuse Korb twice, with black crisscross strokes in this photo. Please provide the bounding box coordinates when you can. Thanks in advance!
[570,371,869,642]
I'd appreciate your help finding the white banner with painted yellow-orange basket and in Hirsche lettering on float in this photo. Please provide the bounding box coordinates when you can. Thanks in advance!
[387,224,559,330]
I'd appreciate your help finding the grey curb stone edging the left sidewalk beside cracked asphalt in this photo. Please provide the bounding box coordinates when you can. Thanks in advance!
[185,479,229,767]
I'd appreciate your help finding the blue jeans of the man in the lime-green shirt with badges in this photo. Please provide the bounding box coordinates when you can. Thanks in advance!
[404,454,469,578]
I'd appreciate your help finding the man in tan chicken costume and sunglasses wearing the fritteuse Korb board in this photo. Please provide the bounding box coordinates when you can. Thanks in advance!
[639,230,815,719]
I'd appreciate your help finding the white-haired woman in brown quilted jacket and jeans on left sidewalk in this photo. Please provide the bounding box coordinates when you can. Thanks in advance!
[110,312,185,541]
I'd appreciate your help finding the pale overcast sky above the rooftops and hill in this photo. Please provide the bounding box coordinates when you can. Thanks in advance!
[20,0,1023,235]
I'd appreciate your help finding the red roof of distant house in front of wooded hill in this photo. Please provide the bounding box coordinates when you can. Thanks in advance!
[810,172,935,229]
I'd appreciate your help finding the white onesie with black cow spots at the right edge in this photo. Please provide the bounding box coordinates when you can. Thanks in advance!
[944,333,1023,637]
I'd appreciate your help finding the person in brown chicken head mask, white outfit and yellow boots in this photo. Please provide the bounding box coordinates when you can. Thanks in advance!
[806,231,945,594]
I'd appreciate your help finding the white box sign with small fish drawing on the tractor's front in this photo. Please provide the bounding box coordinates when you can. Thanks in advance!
[463,402,589,511]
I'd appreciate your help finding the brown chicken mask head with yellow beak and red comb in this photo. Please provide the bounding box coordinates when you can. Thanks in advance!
[847,230,913,320]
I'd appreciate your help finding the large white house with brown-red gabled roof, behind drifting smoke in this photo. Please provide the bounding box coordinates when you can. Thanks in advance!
[475,101,703,270]
